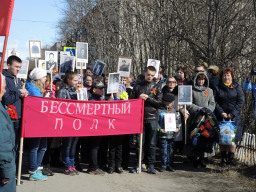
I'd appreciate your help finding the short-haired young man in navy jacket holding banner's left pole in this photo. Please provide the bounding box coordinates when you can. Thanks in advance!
[2,55,28,150]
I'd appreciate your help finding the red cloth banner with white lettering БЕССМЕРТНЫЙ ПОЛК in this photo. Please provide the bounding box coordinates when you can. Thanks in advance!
[22,96,144,137]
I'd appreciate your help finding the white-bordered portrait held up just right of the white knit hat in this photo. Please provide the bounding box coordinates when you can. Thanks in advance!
[45,51,58,73]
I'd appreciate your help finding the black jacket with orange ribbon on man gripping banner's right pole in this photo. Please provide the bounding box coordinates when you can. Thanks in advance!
[131,80,162,119]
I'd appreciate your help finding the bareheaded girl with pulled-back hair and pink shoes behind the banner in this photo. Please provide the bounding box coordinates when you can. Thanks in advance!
[57,72,79,176]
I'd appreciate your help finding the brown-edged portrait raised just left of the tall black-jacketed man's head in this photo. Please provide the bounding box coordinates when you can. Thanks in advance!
[117,57,132,77]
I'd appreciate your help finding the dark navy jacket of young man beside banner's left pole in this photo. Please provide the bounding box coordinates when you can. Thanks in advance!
[2,69,22,119]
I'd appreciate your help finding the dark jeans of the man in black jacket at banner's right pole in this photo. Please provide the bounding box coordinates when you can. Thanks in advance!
[137,119,159,165]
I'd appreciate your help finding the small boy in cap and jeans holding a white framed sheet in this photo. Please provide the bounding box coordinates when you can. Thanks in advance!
[158,93,177,172]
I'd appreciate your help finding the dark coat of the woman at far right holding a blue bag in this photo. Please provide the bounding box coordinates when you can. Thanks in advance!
[214,81,244,141]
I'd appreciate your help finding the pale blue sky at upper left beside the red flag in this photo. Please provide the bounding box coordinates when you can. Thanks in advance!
[0,0,64,59]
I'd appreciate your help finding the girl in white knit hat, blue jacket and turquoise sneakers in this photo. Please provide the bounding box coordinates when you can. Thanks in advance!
[26,68,47,181]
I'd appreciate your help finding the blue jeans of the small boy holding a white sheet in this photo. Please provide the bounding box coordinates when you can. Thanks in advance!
[159,138,174,169]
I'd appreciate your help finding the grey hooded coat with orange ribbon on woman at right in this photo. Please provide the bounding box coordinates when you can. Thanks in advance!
[187,72,215,113]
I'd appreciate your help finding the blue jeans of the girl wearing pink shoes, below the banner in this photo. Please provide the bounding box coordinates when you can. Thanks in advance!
[62,137,79,168]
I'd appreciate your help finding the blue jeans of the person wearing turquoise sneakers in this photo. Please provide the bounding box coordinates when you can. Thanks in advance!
[28,137,47,171]
